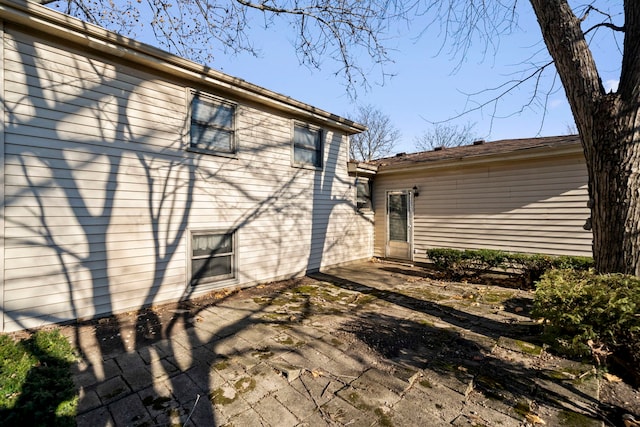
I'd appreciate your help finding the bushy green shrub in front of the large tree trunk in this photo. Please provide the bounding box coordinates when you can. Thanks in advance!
[532,270,640,378]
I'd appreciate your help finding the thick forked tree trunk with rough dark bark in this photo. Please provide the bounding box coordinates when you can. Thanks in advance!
[530,0,640,275]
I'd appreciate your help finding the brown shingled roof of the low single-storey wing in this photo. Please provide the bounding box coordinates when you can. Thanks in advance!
[369,135,581,172]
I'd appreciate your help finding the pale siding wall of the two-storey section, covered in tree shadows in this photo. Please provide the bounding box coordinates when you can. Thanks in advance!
[3,27,372,331]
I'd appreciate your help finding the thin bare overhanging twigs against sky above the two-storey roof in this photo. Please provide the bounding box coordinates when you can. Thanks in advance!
[46,0,404,97]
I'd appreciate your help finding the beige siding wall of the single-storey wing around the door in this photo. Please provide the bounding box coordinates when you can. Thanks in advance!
[374,151,592,262]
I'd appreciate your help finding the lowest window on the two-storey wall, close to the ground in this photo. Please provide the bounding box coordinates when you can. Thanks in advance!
[190,231,236,286]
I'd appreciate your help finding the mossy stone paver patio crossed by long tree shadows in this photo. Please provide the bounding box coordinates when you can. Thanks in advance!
[69,263,601,427]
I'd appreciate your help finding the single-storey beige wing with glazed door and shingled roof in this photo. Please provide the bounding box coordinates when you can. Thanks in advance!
[351,136,592,262]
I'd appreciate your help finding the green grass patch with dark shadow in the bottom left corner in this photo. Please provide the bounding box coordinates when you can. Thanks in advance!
[0,330,78,426]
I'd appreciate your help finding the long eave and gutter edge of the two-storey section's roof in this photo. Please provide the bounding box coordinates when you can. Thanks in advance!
[0,0,366,134]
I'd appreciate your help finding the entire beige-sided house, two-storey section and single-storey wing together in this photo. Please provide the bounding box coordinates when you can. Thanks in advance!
[0,0,591,331]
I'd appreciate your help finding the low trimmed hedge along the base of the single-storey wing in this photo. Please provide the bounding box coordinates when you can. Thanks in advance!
[427,248,593,287]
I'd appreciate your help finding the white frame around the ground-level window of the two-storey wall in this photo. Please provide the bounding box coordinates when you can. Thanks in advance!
[187,228,238,290]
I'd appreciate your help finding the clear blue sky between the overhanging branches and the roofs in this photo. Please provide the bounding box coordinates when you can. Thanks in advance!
[127,2,620,152]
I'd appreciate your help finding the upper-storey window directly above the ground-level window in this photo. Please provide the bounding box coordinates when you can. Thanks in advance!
[189,93,236,155]
